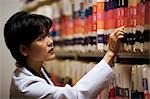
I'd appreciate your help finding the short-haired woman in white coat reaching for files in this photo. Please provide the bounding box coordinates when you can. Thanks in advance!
[4,11,124,99]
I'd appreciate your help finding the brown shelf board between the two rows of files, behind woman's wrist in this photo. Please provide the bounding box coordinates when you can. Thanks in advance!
[56,51,150,64]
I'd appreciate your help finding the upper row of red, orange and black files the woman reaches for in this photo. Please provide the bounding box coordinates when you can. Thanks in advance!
[28,0,150,52]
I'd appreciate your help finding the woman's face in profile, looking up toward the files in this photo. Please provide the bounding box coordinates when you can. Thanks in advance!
[27,34,55,62]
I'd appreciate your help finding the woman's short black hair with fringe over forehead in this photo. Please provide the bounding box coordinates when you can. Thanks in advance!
[4,11,52,66]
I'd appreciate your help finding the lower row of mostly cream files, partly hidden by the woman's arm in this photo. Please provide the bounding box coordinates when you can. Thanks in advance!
[45,60,150,99]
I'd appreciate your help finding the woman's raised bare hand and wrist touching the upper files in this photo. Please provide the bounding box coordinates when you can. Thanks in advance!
[103,26,124,65]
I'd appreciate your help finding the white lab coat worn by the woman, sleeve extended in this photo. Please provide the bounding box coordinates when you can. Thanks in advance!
[10,60,115,99]
